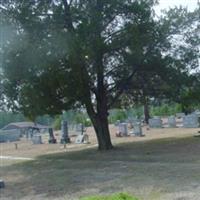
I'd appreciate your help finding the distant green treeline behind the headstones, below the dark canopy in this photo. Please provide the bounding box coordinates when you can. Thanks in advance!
[0,104,189,130]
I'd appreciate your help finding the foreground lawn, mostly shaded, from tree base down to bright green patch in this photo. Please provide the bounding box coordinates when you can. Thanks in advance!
[0,137,200,200]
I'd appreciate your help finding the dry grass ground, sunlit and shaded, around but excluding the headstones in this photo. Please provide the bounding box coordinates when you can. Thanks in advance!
[0,122,200,200]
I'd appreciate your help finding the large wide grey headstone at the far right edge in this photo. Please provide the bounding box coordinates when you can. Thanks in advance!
[183,114,200,128]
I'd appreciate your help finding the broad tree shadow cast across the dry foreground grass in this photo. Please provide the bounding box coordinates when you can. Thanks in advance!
[2,138,200,199]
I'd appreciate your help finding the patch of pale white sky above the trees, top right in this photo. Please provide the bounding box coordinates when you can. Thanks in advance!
[156,0,198,14]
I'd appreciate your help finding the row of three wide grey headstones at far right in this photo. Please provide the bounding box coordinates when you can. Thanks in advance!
[149,113,200,128]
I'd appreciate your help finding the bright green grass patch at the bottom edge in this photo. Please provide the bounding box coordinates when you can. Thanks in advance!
[80,193,138,200]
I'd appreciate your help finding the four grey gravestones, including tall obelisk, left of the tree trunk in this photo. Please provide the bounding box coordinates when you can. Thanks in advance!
[32,121,89,144]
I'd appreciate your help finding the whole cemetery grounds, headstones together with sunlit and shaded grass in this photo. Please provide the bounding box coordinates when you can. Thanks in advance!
[0,106,200,200]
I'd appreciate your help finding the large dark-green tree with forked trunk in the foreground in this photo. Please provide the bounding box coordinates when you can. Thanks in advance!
[1,0,199,150]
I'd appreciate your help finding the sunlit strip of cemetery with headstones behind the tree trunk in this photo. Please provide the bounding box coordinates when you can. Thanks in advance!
[0,116,199,159]
